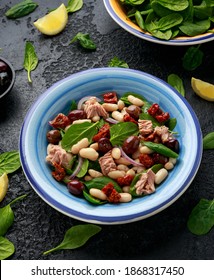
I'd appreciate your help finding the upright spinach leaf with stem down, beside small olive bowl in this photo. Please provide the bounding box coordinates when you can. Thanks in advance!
[24,42,39,83]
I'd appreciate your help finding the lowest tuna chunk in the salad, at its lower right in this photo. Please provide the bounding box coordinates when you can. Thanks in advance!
[135,169,155,195]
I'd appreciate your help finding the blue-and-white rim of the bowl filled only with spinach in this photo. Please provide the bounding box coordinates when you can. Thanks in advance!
[103,0,214,46]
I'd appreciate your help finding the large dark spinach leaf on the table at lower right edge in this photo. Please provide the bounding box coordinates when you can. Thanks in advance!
[187,199,214,235]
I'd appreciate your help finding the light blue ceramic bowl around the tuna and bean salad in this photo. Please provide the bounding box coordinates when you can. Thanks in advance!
[20,68,202,224]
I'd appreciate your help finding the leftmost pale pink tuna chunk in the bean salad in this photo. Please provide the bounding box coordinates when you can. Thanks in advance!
[46,144,72,168]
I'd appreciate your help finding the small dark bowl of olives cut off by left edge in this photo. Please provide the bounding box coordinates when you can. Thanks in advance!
[0,57,16,99]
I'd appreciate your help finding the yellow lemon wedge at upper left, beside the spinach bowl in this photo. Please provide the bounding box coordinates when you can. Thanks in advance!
[33,4,68,35]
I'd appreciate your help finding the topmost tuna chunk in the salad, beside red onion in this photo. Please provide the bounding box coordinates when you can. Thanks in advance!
[84,97,108,119]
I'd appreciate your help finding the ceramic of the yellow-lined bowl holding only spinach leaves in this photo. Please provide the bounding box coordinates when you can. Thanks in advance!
[103,0,214,46]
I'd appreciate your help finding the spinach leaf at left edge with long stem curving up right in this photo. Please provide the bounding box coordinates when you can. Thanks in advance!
[0,195,26,236]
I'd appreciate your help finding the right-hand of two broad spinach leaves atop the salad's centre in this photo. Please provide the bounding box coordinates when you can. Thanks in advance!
[110,122,138,146]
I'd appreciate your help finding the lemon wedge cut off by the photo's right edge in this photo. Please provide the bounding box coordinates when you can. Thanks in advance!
[191,77,214,101]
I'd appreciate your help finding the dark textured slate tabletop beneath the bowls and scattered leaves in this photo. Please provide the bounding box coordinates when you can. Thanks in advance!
[0,0,214,260]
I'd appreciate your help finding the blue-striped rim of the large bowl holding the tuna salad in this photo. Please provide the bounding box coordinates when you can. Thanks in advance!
[19,68,202,224]
